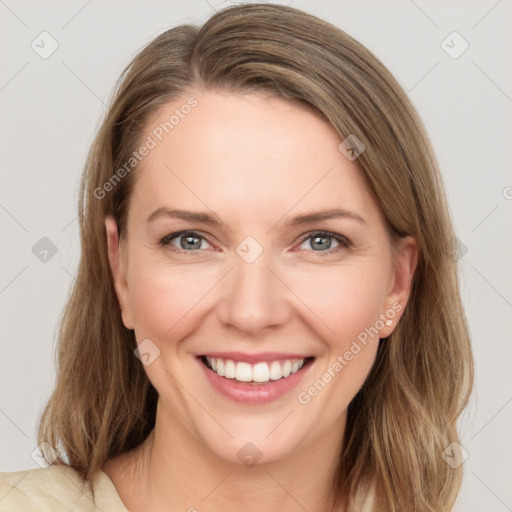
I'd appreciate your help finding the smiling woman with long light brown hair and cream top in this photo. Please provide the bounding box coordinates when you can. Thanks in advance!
[0,4,472,512]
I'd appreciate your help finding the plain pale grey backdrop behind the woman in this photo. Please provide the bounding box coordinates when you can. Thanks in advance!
[0,0,512,512]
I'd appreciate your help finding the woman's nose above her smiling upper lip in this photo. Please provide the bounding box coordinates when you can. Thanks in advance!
[217,252,290,335]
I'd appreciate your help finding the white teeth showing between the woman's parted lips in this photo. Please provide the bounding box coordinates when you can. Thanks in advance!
[199,355,314,384]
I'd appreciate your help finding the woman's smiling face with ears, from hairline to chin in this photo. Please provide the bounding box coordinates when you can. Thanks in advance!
[106,92,416,463]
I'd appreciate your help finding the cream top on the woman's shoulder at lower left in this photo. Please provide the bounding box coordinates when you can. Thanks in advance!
[0,465,128,512]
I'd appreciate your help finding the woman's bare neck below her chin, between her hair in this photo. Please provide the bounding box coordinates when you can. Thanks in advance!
[103,407,345,512]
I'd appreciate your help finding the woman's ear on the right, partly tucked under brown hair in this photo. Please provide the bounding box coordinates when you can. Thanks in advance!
[379,236,418,338]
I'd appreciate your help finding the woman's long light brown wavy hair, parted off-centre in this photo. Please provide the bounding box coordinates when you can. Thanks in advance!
[39,4,473,512]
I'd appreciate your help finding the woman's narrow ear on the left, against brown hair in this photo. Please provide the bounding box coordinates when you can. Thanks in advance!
[105,215,134,329]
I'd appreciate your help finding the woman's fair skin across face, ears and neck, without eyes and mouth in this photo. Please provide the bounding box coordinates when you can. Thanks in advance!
[104,91,417,512]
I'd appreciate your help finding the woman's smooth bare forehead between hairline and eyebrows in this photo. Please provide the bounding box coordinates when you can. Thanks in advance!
[130,92,380,230]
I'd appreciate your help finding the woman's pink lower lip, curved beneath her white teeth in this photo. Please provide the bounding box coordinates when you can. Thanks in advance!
[197,358,312,405]
